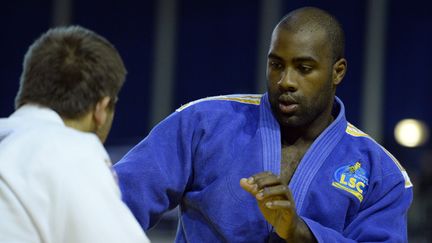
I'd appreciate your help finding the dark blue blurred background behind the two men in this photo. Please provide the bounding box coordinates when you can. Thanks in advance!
[0,0,432,242]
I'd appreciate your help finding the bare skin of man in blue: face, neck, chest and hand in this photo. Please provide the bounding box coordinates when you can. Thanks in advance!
[240,16,347,242]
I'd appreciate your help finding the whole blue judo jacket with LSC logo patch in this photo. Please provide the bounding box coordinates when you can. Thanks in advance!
[114,94,412,242]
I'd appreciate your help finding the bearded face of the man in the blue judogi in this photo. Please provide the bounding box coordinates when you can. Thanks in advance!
[267,28,336,127]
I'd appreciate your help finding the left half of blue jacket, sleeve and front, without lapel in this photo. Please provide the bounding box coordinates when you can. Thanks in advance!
[114,95,271,243]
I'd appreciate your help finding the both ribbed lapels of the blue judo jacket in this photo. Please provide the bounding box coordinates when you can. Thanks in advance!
[260,93,347,212]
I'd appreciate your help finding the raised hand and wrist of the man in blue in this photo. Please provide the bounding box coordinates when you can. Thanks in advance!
[240,172,315,242]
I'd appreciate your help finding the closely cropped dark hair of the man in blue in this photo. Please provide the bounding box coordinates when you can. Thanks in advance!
[276,7,345,62]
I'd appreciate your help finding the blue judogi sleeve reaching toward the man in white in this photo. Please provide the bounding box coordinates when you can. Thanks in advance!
[114,112,200,230]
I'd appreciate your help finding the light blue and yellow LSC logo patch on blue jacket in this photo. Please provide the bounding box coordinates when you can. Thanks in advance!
[332,162,369,202]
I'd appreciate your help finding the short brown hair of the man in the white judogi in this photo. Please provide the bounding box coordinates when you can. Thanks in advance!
[15,26,126,119]
